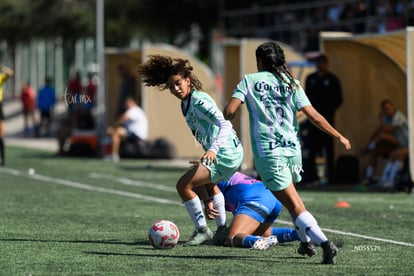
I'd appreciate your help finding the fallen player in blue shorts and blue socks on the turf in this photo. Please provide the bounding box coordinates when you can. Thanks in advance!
[205,172,299,250]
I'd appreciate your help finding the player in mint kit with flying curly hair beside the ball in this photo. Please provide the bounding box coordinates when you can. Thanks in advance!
[138,55,243,245]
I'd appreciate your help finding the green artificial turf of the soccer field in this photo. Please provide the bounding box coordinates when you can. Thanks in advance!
[0,147,414,275]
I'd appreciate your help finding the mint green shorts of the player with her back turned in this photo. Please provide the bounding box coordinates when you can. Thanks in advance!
[254,154,303,191]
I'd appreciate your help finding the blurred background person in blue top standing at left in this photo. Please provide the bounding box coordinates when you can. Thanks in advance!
[37,77,56,136]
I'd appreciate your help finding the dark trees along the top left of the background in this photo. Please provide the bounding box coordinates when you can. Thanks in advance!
[0,0,219,74]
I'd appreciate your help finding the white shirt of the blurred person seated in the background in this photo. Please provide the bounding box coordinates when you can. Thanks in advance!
[125,106,148,140]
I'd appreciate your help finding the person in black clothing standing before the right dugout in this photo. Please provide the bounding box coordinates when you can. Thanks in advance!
[305,54,343,183]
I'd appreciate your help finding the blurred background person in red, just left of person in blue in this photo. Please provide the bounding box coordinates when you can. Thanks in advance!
[20,82,36,137]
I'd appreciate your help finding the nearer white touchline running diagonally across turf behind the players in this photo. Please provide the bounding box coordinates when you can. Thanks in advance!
[0,168,414,247]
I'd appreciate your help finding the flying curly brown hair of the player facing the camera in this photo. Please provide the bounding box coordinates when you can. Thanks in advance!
[138,55,202,90]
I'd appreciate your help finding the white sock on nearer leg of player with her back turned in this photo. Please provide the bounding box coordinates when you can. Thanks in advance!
[295,211,328,245]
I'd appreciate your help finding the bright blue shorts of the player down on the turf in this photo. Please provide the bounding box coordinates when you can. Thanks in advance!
[233,185,282,223]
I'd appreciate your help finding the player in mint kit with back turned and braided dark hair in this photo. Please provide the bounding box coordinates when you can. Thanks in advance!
[223,42,351,264]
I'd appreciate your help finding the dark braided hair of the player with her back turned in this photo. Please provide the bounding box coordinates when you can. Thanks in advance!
[256,42,297,91]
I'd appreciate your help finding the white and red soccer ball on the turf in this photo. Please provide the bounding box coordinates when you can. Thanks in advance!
[148,220,180,249]
